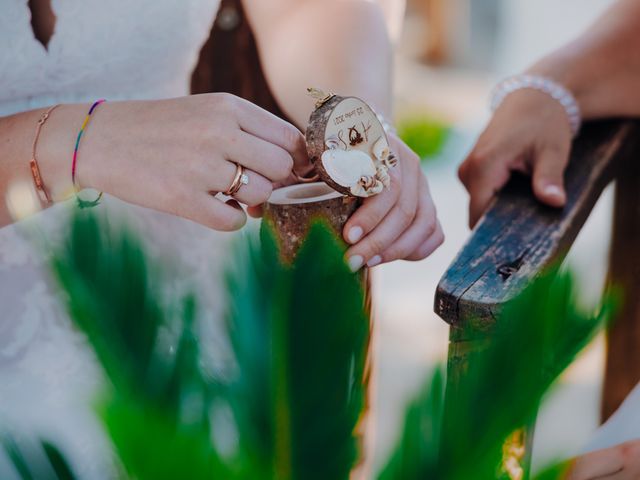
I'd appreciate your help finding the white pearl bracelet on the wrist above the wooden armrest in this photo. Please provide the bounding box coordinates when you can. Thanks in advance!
[491,75,582,138]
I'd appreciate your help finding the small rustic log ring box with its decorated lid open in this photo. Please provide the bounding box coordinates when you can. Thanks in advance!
[264,89,396,263]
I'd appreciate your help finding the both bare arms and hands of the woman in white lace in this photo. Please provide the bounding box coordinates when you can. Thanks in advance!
[0,0,443,270]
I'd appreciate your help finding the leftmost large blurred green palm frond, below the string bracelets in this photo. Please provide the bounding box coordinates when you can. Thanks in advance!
[48,211,221,479]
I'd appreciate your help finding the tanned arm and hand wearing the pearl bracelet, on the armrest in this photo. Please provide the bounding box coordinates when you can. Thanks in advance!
[459,0,640,226]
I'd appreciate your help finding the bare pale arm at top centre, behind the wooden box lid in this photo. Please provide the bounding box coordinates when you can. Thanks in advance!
[248,0,392,127]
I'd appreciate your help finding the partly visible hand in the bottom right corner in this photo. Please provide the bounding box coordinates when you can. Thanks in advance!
[567,440,640,480]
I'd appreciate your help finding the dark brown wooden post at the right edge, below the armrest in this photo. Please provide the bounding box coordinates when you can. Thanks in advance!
[602,155,640,422]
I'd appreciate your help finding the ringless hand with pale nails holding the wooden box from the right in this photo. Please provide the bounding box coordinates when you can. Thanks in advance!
[343,135,444,271]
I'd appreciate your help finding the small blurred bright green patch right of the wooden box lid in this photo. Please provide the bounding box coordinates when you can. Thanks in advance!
[397,114,450,161]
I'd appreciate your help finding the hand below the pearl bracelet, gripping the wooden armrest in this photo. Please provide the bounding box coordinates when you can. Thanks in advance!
[459,90,572,227]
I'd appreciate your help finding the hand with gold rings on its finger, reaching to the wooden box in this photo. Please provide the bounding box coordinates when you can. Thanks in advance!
[65,94,308,231]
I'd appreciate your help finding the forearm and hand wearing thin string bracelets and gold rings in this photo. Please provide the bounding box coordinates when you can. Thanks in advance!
[0,93,308,231]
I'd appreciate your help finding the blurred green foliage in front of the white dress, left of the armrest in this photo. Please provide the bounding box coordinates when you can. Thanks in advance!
[5,211,369,480]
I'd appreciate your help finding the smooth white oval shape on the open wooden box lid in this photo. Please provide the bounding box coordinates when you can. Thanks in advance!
[322,149,376,189]
